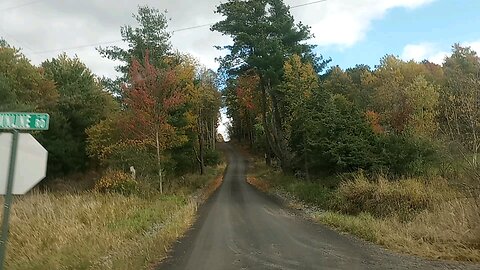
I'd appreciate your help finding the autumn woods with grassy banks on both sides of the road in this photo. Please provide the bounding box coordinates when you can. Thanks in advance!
[0,0,480,269]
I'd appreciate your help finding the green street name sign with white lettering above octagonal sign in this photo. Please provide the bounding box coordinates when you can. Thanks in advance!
[0,112,50,130]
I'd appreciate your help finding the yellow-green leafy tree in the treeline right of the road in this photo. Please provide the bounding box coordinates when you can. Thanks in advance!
[363,56,439,137]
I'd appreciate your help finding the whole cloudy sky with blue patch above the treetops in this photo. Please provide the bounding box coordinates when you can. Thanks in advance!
[0,0,480,138]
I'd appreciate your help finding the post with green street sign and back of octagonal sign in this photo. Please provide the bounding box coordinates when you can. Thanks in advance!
[0,112,50,270]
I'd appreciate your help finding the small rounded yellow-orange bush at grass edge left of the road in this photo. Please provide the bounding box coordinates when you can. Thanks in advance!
[95,170,137,195]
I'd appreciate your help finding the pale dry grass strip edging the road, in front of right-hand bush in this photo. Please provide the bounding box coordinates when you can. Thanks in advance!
[314,196,480,262]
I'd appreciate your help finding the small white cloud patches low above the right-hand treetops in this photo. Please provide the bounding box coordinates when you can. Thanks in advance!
[400,40,480,65]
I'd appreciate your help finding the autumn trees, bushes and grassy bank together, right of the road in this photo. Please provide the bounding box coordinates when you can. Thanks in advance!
[212,0,480,261]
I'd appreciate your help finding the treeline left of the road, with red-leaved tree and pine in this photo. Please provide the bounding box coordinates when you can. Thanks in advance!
[0,6,221,192]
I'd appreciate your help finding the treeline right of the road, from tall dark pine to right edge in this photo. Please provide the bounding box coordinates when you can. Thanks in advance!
[218,0,480,179]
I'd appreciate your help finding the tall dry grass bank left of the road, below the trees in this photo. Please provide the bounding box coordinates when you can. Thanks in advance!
[2,165,225,270]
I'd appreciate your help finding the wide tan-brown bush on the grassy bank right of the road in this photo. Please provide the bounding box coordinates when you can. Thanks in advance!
[334,174,453,221]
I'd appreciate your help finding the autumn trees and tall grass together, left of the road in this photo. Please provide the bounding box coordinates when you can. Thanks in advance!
[0,6,225,269]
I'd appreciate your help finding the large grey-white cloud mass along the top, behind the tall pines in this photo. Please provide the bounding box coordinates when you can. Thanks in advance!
[0,0,434,76]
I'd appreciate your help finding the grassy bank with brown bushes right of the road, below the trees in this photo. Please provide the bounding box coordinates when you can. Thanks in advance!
[247,156,480,262]
